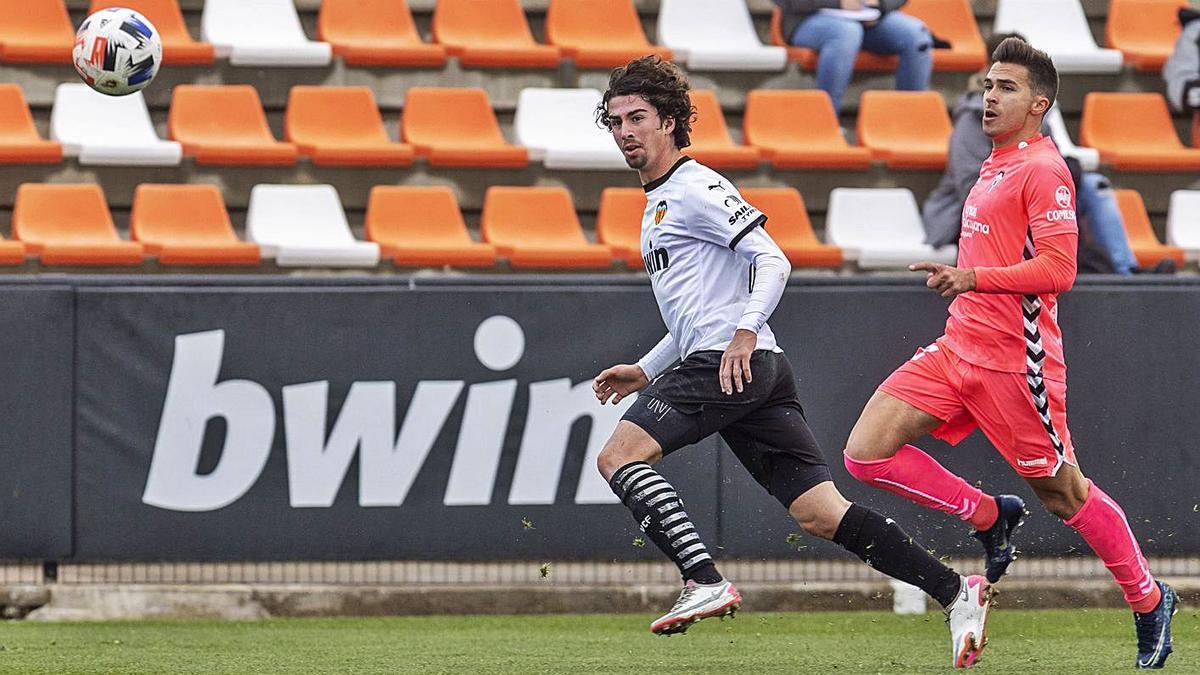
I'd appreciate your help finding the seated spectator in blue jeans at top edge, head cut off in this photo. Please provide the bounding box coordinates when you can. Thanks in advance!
[774,0,934,112]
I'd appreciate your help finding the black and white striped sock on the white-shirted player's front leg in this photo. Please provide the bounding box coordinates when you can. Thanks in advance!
[608,461,722,584]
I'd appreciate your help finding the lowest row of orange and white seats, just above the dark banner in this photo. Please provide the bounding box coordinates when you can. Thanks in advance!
[0,184,1200,269]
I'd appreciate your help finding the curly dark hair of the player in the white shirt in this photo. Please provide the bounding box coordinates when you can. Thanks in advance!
[595,55,696,150]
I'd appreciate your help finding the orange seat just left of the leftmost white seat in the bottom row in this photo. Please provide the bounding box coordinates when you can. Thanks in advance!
[130,184,260,265]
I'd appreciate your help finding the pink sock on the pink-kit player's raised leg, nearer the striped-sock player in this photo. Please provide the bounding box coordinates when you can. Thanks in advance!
[844,446,997,530]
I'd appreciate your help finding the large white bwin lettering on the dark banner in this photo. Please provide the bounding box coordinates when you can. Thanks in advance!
[142,316,635,512]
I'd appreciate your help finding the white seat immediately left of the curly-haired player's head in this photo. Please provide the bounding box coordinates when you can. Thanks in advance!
[512,88,629,169]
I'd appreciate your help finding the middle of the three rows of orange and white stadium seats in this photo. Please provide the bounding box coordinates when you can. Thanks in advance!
[9,83,1200,171]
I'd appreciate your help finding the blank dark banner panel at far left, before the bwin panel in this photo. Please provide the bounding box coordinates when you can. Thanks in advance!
[0,286,74,560]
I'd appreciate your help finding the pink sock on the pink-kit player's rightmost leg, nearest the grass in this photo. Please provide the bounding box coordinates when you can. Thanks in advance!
[1067,480,1162,613]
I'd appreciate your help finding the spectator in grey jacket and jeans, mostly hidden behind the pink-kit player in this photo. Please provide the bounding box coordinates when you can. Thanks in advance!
[922,34,1147,275]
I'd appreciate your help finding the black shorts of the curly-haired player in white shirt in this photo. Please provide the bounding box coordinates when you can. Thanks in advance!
[622,350,832,507]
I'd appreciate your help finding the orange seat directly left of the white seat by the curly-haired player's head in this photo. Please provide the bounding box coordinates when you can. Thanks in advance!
[400,86,529,168]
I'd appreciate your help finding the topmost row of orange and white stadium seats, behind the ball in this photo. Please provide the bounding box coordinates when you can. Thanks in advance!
[0,0,1187,72]
